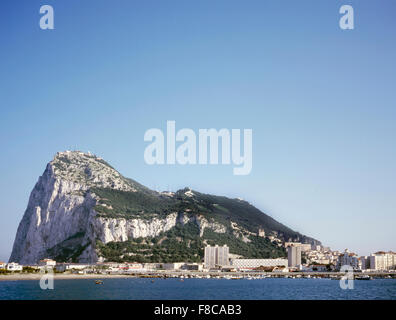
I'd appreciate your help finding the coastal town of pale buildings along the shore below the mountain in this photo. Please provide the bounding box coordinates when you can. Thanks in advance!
[0,242,396,278]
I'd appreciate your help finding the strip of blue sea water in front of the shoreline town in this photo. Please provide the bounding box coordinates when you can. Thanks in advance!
[0,278,396,300]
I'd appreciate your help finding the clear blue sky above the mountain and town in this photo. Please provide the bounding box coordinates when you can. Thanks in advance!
[0,0,396,261]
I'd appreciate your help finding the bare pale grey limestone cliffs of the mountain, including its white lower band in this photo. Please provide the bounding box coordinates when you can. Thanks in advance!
[9,151,224,264]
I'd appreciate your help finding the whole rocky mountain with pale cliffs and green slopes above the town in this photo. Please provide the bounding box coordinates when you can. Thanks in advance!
[10,151,320,264]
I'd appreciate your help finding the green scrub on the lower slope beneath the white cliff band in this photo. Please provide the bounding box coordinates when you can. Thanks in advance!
[97,222,286,263]
